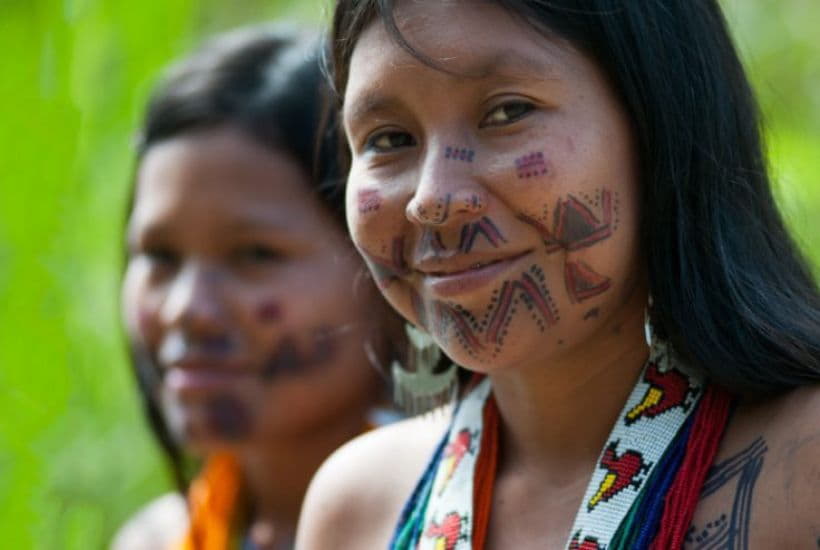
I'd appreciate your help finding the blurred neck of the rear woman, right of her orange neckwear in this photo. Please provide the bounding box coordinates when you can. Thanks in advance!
[235,408,367,550]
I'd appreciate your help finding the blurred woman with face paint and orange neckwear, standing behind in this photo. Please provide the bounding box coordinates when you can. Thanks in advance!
[114,24,408,549]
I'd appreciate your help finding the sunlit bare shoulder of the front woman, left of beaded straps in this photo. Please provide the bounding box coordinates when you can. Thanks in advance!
[296,414,447,550]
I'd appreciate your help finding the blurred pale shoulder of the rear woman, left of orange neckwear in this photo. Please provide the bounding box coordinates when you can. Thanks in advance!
[111,493,188,550]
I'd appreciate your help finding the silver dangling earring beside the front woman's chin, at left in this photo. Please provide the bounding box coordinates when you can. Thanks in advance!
[391,323,458,416]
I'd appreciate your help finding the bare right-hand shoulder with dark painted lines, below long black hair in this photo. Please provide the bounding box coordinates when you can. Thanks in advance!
[686,385,820,549]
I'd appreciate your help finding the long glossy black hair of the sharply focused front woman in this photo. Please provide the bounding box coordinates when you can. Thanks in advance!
[325,0,820,394]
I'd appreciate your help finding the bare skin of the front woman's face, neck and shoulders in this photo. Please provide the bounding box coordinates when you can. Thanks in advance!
[297,2,820,550]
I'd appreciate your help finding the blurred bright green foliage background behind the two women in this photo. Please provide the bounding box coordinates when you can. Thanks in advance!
[0,0,820,550]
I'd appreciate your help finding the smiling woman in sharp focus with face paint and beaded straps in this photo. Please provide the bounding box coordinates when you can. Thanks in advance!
[297,0,820,550]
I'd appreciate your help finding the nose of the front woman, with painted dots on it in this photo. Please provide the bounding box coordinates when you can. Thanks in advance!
[405,147,487,226]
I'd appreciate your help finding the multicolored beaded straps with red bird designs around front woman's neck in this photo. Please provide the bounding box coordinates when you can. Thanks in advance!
[390,344,729,550]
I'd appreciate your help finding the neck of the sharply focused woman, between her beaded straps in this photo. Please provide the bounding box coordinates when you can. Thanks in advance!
[491,292,649,486]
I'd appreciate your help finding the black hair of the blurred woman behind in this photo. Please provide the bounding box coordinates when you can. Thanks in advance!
[128,25,344,490]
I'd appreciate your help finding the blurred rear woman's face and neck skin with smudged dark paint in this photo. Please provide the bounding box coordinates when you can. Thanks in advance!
[123,127,384,548]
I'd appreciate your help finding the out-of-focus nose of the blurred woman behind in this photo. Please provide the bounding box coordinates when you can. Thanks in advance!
[160,262,227,335]
